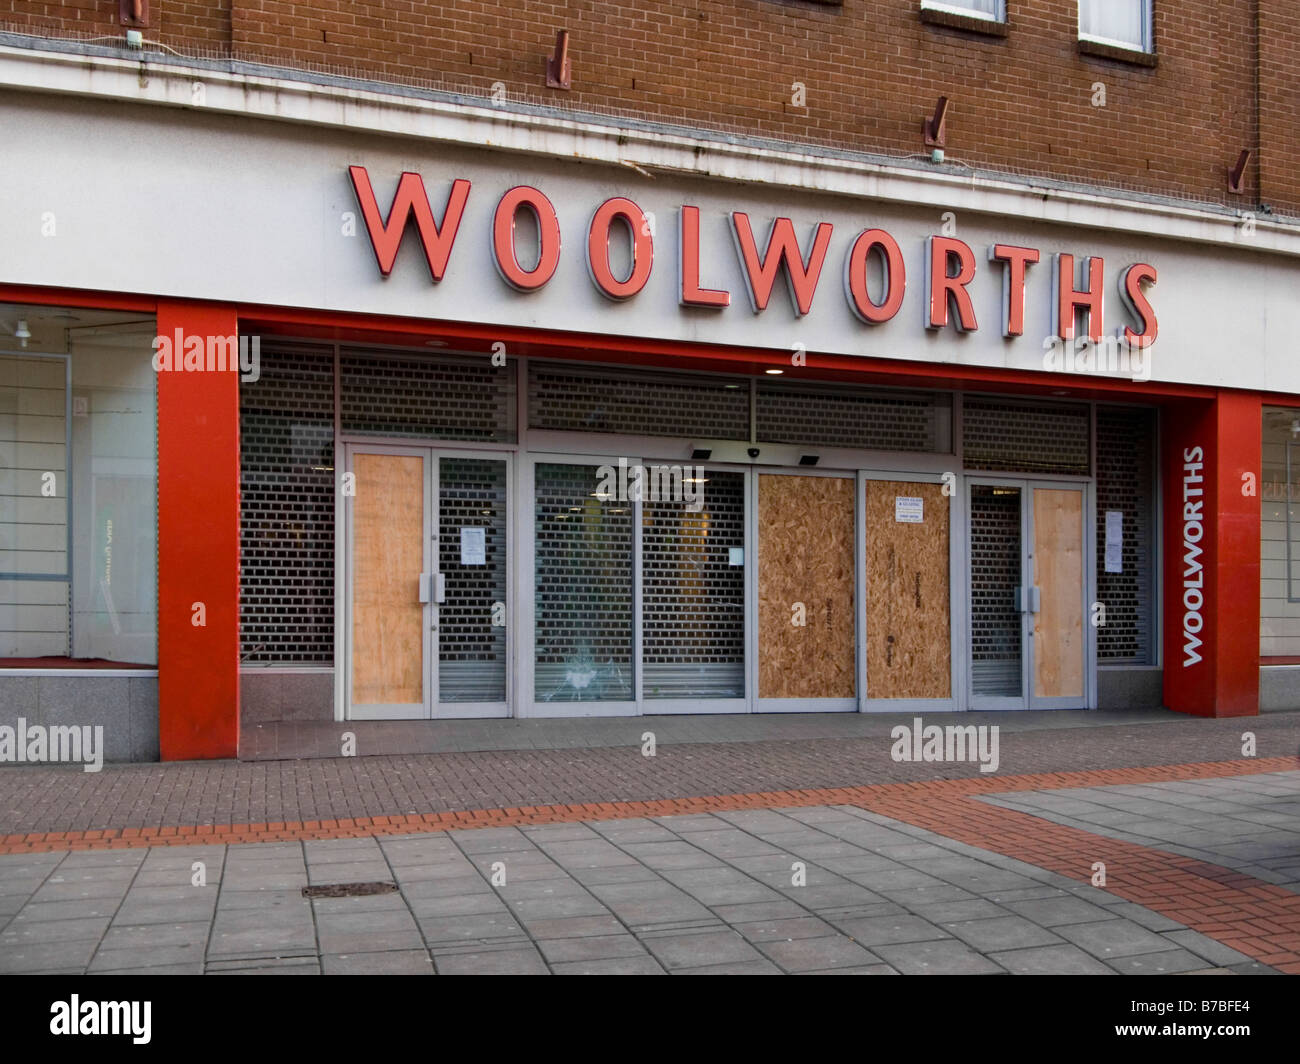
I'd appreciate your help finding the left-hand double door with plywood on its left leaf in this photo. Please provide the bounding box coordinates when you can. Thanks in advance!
[342,445,510,719]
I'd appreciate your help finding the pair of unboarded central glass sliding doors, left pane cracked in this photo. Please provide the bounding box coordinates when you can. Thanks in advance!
[524,455,750,717]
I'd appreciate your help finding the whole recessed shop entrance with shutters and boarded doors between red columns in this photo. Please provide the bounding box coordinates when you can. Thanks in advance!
[241,343,1153,723]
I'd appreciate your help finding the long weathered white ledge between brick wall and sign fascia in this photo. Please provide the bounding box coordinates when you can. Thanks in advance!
[0,46,1300,256]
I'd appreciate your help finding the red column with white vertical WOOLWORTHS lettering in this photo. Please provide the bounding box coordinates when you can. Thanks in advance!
[1161,392,1262,717]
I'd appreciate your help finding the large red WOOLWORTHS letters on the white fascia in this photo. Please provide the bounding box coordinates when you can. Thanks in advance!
[348,166,1158,347]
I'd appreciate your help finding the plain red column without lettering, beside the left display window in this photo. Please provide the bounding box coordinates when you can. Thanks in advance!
[157,299,239,761]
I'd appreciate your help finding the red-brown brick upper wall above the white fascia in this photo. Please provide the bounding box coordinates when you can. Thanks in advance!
[0,0,1300,213]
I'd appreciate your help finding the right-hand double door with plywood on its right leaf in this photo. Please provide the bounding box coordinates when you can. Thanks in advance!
[967,479,1093,709]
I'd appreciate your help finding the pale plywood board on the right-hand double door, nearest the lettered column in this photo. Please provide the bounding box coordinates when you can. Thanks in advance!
[1034,488,1084,698]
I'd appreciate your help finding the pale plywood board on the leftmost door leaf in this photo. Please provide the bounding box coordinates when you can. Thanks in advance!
[352,454,424,705]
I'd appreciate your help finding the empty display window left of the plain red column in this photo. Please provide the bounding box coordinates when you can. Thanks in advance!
[0,308,157,665]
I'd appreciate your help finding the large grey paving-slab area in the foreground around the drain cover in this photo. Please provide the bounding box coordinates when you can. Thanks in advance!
[0,801,1294,974]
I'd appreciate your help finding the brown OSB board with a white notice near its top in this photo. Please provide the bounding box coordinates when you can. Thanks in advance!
[866,480,952,698]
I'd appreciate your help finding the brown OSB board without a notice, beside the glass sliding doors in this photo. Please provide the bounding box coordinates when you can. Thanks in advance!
[758,473,857,698]
